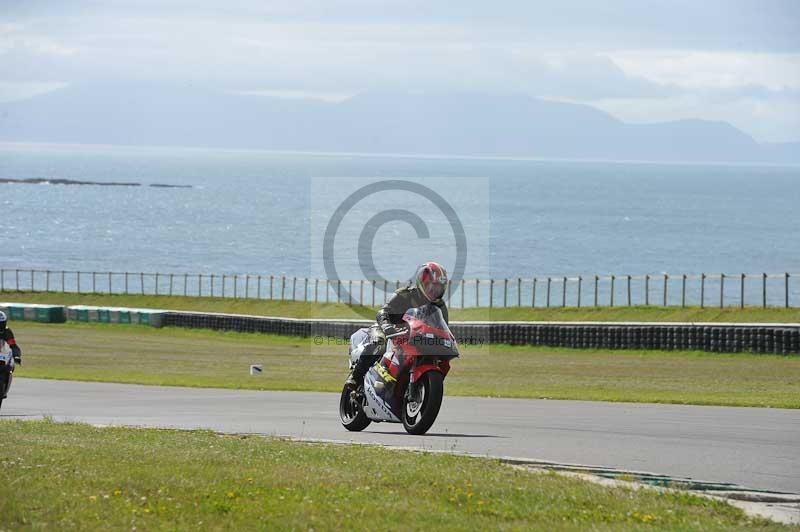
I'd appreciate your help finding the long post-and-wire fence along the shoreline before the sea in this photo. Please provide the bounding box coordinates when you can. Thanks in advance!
[0,269,800,308]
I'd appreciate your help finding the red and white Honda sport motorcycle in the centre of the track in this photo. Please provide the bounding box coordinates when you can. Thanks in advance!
[339,304,459,434]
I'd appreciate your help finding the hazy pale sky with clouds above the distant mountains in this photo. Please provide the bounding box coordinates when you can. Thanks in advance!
[0,0,800,141]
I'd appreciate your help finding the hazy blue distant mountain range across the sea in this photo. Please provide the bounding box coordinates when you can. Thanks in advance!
[0,83,800,163]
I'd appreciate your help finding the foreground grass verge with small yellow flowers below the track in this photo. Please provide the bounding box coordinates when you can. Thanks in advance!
[0,421,787,531]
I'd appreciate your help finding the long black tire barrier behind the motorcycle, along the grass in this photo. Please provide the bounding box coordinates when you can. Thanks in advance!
[158,311,800,355]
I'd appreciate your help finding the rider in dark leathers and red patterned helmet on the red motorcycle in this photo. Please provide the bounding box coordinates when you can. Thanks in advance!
[346,262,450,387]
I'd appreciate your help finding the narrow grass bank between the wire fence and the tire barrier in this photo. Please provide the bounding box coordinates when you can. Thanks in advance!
[0,291,800,323]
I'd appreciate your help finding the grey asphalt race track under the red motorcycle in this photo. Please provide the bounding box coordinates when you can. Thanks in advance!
[6,378,800,493]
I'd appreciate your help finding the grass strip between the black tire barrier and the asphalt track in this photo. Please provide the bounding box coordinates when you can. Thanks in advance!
[13,322,800,408]
